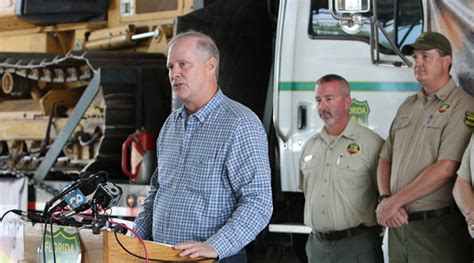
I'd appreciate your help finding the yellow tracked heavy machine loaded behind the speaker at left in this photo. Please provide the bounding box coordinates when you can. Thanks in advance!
[0,0,196,180]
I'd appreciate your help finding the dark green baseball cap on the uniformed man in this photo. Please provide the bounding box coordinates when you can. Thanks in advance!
[402,32,453,56]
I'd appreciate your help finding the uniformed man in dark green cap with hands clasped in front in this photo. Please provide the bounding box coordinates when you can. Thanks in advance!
[376,32,474,263]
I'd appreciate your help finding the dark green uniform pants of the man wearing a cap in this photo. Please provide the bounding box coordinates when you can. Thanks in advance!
[388,213,471,263]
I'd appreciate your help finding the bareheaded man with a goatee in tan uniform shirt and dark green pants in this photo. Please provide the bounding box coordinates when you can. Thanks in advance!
[300,75,383,263]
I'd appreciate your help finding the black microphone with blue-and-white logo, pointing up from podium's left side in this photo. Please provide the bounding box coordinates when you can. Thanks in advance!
[43,171,108,217]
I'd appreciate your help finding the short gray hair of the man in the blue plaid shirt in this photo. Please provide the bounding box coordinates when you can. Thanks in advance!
[168,30,220,79]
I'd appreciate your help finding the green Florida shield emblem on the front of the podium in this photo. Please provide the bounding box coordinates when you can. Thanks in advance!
[38,227,81,263]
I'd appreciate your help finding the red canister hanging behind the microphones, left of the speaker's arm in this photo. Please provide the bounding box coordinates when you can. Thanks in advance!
[122,131,156,184]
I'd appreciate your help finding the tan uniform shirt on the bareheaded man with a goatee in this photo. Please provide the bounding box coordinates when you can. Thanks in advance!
[300,121,383,232]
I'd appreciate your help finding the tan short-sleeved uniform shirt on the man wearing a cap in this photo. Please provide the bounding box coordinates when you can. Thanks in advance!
[380,79,474,212]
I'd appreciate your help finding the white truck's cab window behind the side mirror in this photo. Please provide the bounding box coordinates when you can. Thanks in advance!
[309,0,423,54]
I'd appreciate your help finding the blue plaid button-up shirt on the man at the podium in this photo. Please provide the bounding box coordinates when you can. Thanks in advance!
[135,90,273,258]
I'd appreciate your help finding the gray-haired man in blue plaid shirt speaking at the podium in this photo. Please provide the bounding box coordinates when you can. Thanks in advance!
[135,31,273,262]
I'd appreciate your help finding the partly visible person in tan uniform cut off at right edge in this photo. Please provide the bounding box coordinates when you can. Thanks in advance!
[453,112,474,238]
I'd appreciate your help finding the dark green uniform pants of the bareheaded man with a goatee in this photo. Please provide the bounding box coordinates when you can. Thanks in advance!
[306,228,383,263]
